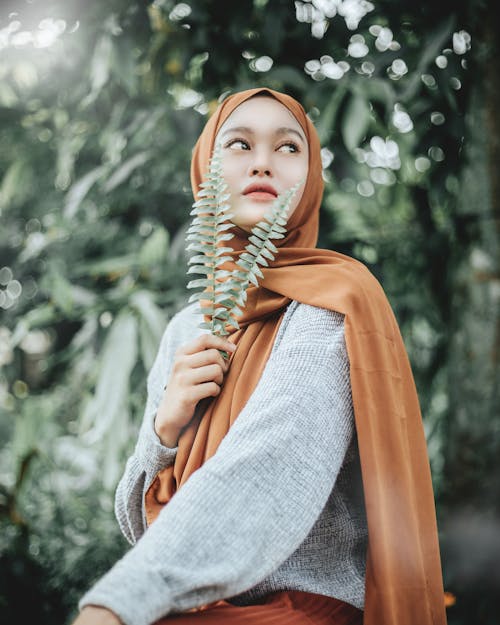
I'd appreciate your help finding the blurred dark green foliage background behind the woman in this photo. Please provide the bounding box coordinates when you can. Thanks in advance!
[0,0,500,625]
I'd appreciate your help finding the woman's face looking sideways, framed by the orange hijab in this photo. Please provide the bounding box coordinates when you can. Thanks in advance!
[216,97,309,232]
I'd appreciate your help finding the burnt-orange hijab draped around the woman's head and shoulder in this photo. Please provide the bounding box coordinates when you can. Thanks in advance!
[145,89,446,625]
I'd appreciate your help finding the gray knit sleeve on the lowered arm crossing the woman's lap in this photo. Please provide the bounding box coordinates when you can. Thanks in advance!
[80,305,354,625]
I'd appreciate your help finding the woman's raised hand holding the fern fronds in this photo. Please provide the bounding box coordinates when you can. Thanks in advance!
[155,334,236,447]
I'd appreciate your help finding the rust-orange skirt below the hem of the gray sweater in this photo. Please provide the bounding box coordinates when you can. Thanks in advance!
[155,590,363,625]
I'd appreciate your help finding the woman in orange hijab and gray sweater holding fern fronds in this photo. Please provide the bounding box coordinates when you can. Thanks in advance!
[75,89,446,625]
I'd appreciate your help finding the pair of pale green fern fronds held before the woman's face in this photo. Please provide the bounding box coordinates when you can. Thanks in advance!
[186,144,301,336]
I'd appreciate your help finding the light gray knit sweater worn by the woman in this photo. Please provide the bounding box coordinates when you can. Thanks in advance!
[79,302,367,625]
